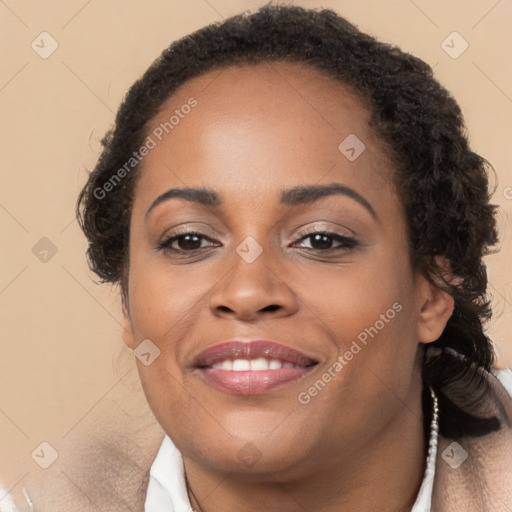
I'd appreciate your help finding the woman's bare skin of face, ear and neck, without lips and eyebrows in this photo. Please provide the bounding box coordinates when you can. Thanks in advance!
[123,62,453,512]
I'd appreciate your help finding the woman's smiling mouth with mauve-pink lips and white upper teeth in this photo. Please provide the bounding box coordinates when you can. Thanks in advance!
[195,340,318,395]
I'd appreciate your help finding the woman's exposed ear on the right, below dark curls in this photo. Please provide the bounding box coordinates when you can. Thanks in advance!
[416,257,455,343]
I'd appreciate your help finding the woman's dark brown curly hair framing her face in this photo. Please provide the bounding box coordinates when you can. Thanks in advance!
[77,4,499,437]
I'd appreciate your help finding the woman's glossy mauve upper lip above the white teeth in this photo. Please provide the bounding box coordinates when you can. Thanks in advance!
[194,339,317,367]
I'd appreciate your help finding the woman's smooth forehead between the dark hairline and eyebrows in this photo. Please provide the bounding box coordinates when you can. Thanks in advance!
[134,61,391,208]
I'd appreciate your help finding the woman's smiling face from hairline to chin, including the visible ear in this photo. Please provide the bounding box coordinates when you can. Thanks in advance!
[124,63,449,473]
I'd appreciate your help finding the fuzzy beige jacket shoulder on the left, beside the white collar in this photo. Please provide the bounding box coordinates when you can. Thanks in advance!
[0,378,164,512]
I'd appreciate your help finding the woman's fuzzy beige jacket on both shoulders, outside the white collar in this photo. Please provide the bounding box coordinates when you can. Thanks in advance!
[0,364,512,512]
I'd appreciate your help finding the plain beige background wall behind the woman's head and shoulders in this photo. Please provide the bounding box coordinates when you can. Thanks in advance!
[0,0,512,499]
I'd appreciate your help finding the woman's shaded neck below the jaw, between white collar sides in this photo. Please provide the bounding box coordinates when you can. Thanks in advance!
[184,385,428,512]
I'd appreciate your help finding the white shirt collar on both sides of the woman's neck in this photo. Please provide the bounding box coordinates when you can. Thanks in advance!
[144,390,439,512]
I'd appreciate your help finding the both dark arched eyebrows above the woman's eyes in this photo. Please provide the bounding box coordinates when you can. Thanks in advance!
[146,183,379,220]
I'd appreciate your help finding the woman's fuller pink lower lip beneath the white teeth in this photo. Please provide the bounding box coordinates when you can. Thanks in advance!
[199,366,313,395]
